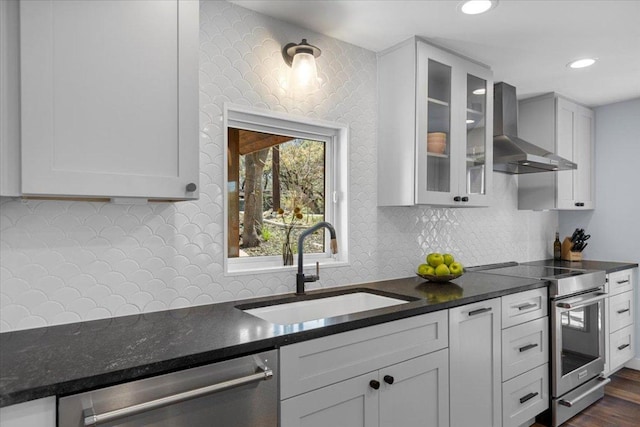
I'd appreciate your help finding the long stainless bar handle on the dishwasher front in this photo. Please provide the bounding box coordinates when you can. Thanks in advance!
[82,368,273,427]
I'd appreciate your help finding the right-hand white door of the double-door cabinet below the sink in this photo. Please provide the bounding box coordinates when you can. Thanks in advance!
[380,349,449,427]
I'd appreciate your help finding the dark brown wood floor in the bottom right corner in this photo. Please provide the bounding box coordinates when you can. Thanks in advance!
[533,368,640,427]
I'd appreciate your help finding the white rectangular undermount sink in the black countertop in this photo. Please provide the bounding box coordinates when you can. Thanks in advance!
[243,292,409,325]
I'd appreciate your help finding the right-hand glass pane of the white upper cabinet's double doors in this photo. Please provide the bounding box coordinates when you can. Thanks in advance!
[465,74,488,195]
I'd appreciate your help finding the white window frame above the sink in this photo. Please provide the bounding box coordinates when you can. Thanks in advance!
[223,103,349,276]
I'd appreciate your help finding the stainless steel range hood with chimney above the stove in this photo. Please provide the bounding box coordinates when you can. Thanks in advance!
[493,82,578,174]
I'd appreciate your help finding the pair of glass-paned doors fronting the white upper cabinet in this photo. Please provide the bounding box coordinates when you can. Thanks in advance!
[416,43,493,207]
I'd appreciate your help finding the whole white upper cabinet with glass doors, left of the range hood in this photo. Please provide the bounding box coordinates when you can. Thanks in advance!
[378,39,493,207]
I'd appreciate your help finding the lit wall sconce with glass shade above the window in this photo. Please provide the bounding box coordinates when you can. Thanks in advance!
[282,39,321,93]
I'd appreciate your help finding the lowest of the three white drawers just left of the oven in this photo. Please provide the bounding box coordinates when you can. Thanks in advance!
[502,363,549,427]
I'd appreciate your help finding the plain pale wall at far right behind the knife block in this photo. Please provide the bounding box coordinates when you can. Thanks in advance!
[559,98,640,368]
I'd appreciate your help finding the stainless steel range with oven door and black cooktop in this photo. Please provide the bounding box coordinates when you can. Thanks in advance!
[472,263,609,427]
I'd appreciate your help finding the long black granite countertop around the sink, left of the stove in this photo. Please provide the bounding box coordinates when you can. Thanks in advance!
[0,273,547,406]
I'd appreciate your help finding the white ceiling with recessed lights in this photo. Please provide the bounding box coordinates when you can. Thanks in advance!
[231,0,640,106]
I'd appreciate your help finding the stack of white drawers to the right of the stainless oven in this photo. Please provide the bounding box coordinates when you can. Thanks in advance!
[604,268,638,376]
